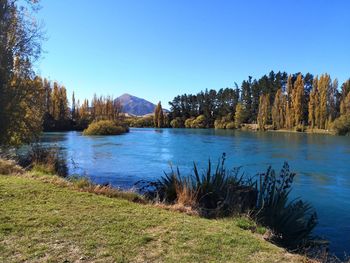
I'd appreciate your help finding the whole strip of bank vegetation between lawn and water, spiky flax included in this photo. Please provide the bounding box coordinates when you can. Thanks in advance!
[0,147,342,261]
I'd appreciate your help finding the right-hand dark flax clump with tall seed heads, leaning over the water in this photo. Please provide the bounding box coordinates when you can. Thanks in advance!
[256,163,317,250]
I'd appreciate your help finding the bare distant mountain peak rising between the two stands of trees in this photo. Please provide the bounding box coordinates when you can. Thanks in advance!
[116,93,156,116]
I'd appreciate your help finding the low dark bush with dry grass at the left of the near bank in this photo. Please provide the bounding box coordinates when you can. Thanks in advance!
[18,144,68,177]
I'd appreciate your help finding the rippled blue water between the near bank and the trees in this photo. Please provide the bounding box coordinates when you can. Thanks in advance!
[43,129,350,256]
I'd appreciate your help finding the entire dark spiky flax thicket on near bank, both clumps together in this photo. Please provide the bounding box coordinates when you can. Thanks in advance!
[140,155,319,255]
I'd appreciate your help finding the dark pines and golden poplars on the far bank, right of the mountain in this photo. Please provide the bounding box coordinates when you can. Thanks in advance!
[169,71,350,130]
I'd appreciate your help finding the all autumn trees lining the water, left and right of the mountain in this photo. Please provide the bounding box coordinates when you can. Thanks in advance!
[0,0,350,150]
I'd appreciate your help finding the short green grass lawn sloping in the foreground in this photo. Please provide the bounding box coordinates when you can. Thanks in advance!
[0,176,303,262]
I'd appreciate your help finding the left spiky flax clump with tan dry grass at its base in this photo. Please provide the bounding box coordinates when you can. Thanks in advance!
[137,154,257,218]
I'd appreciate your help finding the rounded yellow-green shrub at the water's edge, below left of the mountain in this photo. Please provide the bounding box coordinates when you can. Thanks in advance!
[83,120,129,135]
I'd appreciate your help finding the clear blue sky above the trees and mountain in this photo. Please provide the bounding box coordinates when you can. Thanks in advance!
[38,0,350,107]
